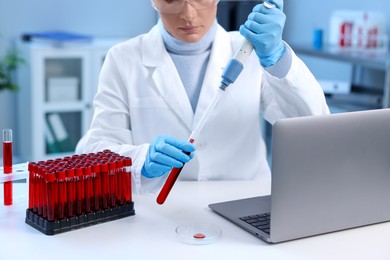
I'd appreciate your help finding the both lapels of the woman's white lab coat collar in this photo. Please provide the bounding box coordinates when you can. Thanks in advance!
[141,25,233,131]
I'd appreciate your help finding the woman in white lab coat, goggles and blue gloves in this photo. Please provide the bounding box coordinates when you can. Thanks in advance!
[76,0,329,194]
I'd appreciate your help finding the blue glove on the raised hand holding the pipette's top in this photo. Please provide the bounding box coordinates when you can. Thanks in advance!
[240,0,286,67]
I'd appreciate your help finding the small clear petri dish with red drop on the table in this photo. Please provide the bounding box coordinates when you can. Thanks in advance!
[175,223,222,245]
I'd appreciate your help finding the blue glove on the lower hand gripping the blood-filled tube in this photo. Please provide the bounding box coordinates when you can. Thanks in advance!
[141,136,195,178]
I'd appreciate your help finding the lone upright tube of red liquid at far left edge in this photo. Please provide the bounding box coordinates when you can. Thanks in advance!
[3,129,12,206]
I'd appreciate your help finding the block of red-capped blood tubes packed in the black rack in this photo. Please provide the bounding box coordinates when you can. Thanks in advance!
[28,150,132,221]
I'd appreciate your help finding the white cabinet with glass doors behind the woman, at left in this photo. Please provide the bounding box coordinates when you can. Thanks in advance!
[16,39,120,161]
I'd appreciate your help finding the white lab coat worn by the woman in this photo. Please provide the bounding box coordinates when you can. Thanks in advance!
[78,26,329,193]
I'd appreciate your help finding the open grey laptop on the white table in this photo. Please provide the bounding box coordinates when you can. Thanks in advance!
[209,109,390,243]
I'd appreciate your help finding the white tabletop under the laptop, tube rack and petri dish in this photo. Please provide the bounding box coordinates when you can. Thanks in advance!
[0,180,390,260]
